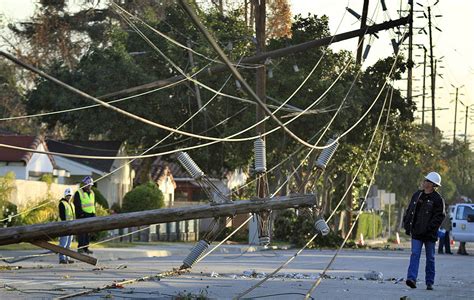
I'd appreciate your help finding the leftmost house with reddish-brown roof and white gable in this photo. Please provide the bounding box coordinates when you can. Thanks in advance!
[0,135,69,183]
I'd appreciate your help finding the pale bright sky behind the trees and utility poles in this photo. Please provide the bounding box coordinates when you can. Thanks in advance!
[0,0,474,141]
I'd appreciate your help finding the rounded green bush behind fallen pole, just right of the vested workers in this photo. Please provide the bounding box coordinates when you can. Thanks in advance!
[122,182,165,212]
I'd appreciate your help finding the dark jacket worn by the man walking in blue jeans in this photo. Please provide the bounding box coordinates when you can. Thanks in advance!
[403,191,445,242]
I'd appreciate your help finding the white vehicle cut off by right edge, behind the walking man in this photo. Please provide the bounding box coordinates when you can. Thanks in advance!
[450,203,474,242]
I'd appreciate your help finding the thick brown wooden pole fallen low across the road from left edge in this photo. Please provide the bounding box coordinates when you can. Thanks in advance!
[0,194,316,245]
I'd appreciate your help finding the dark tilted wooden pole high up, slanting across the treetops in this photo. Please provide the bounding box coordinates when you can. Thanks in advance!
[100,17,410,98]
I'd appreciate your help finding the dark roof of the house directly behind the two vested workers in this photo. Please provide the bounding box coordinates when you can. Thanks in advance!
[46,139,122,172]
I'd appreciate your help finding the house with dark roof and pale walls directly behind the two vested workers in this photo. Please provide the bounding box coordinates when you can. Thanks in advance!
[47,139,134,207]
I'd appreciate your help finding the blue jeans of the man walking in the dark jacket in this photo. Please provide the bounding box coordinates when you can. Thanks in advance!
[407,239,435,285]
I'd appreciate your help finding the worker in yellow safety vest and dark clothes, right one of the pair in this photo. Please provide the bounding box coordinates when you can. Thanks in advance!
[74,176,95,254]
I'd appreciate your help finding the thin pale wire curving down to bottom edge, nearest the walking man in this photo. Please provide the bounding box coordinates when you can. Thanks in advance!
[305,88,393,299]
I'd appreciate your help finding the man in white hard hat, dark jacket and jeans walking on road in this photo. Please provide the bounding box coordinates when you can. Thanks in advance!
[403,172,445,290]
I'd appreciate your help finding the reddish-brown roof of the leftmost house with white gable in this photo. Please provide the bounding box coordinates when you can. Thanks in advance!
[0,135,44,165]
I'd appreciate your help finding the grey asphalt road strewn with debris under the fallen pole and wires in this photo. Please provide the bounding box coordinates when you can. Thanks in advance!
[0,245,474,300]
